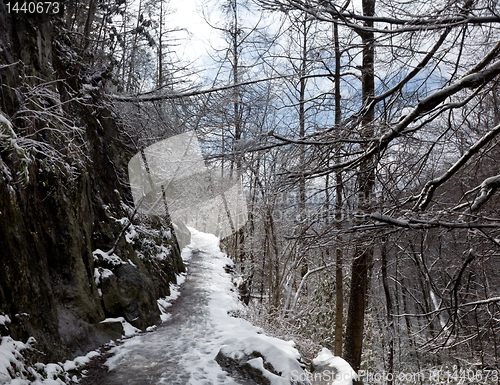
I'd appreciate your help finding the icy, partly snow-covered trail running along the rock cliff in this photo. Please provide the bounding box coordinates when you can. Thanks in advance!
[98,229,300,385]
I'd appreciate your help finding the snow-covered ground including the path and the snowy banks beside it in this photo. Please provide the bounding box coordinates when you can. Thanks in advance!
[0,229,355,385]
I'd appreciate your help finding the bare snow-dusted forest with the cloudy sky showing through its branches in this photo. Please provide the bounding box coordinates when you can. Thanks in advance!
[0,0,500,385]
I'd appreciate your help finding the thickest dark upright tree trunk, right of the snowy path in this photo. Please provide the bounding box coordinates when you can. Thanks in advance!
[344,0,375,372]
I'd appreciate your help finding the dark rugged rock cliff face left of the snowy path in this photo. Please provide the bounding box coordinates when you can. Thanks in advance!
[0,6,184,361]
